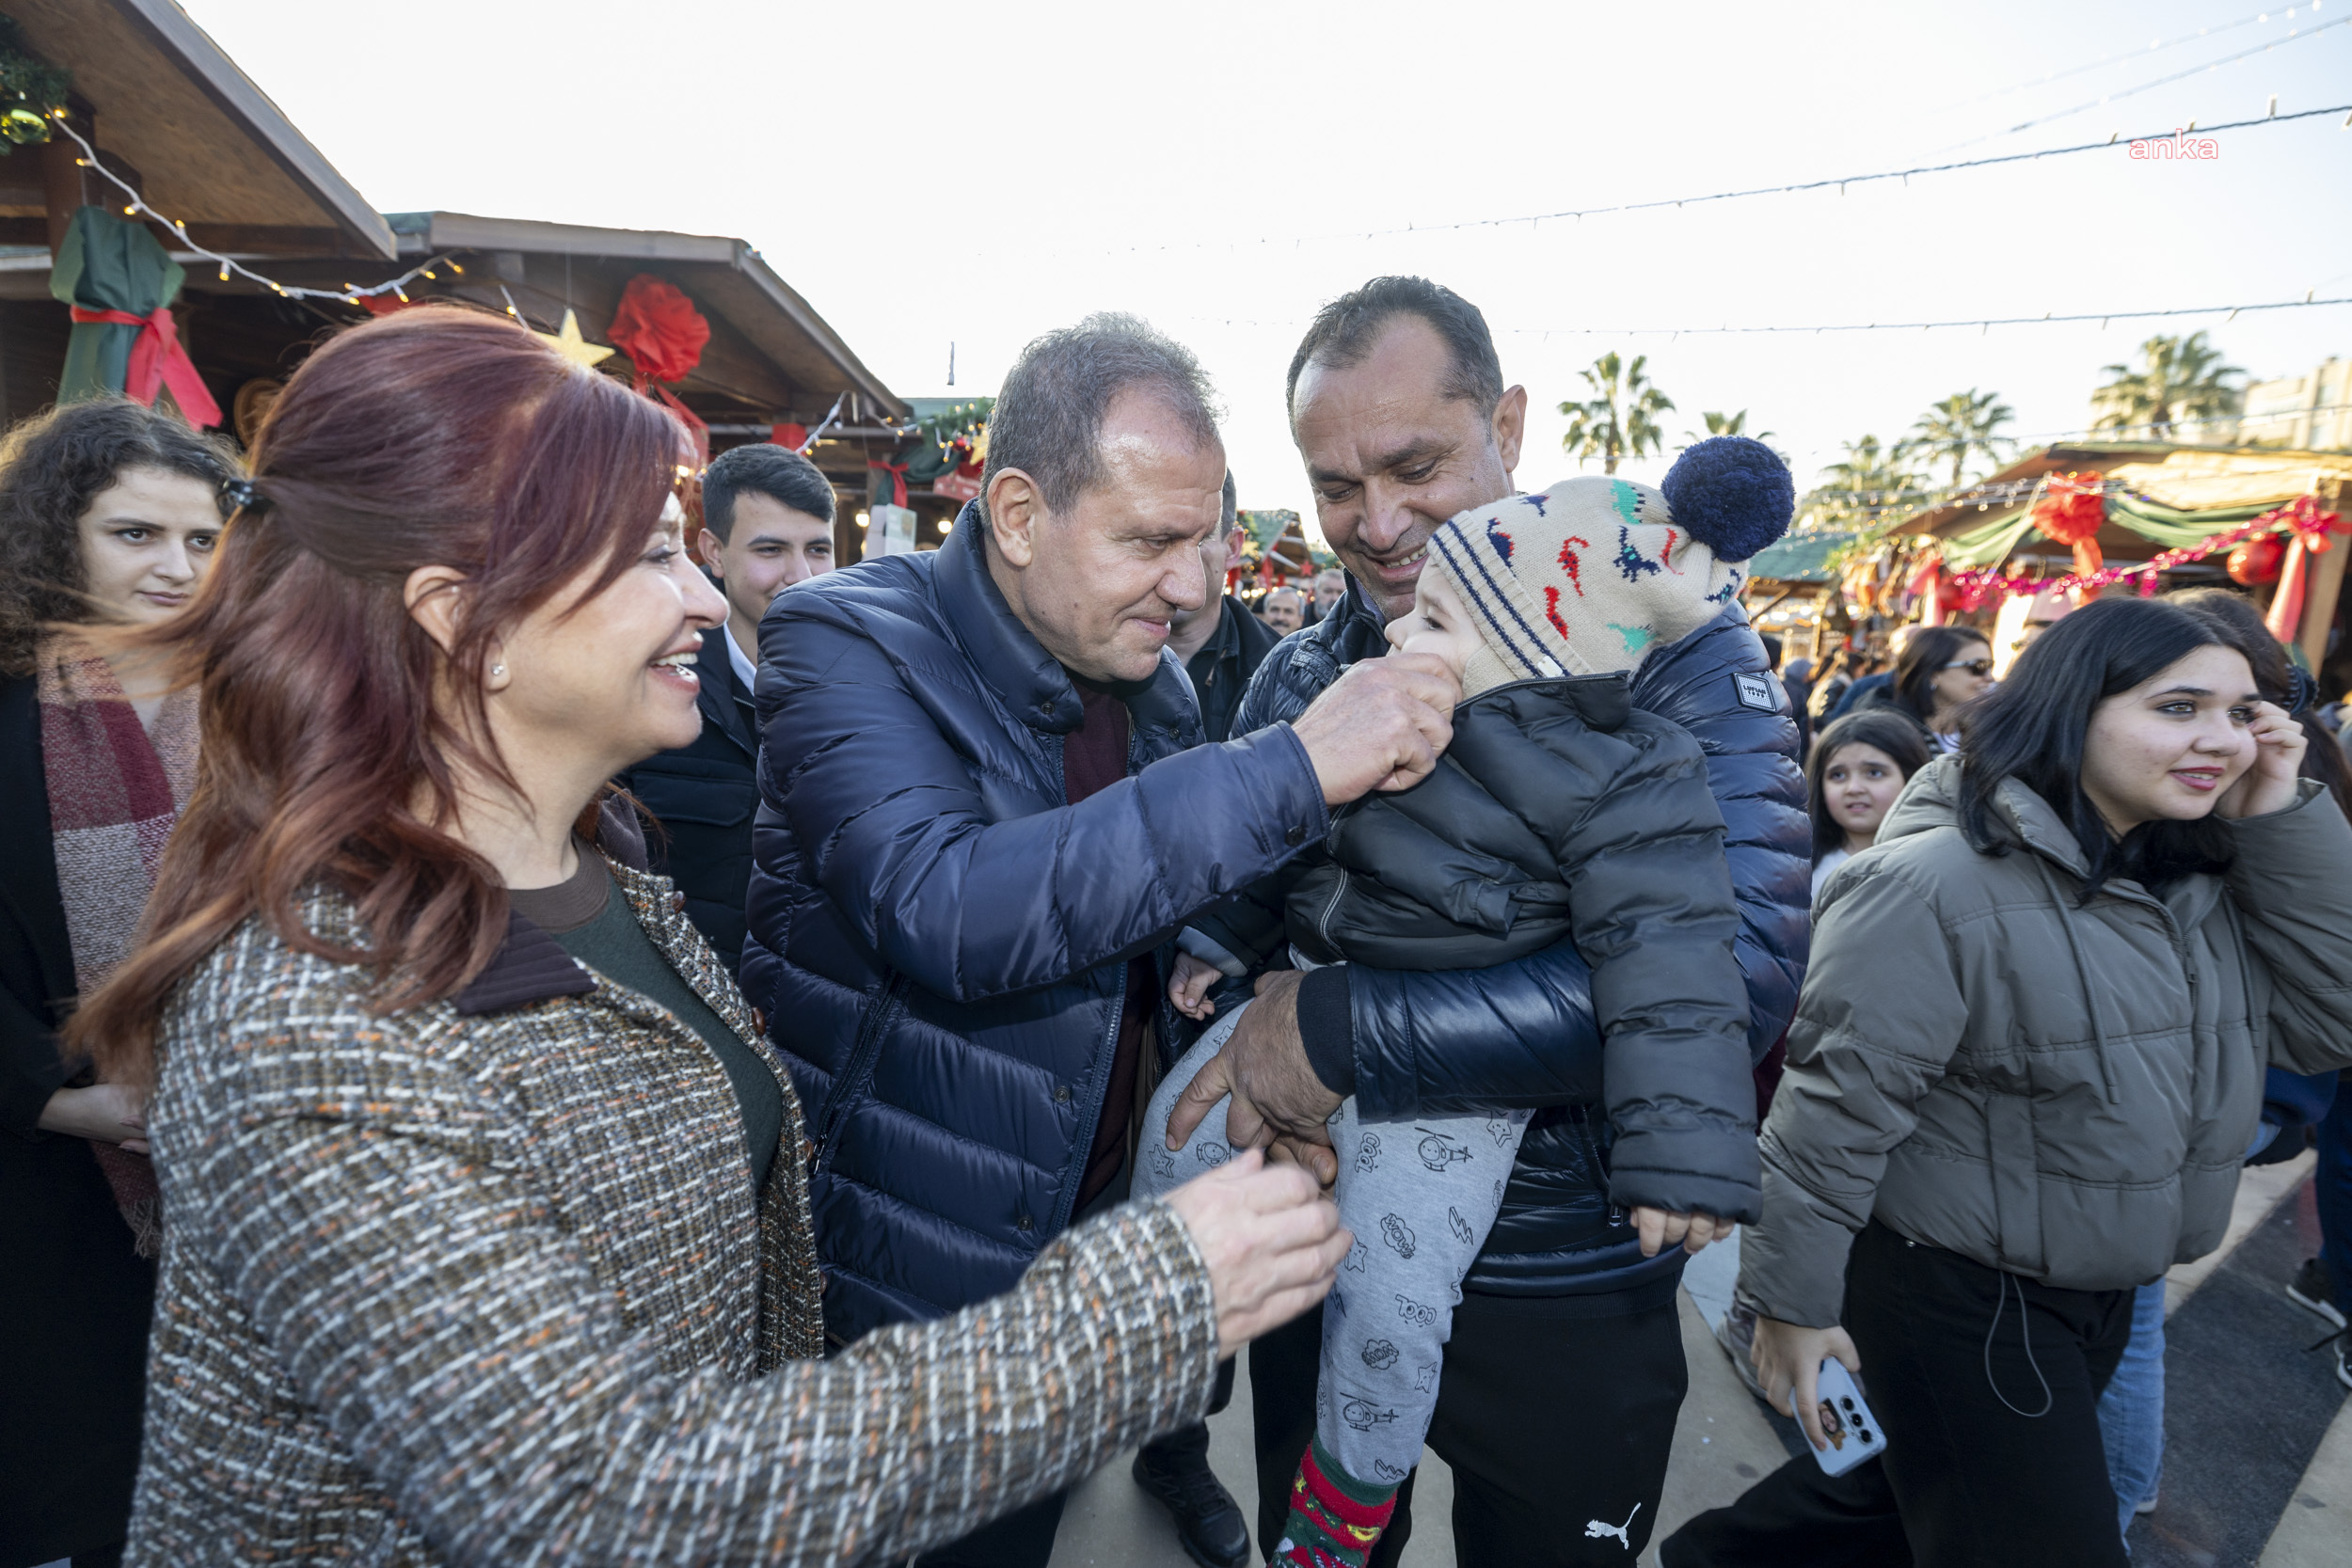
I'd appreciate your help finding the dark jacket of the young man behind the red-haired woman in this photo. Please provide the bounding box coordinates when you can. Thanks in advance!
[616,626,760,974]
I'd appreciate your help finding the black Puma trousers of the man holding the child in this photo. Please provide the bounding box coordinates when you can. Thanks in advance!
[1249,1295,1689,1568]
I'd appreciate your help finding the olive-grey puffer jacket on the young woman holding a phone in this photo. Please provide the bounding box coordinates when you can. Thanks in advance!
[1740,757,2352,1328]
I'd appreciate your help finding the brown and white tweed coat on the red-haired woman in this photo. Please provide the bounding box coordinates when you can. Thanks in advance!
[127,865,1216,1568]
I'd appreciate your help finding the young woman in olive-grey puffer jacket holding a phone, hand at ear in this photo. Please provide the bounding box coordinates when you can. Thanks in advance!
[1663,599,2352,1568]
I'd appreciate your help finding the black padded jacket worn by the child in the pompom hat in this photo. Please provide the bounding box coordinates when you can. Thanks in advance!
[1198,674,1759,1220]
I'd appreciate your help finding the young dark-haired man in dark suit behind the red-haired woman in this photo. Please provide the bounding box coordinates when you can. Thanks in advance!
[619,444,835,969]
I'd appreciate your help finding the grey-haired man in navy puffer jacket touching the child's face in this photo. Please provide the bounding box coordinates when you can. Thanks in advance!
[741,317,1461,1568]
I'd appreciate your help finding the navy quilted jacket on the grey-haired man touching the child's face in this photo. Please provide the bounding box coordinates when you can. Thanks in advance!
[743,505,1329,1340]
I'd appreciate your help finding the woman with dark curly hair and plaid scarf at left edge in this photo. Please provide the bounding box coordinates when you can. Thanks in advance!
[0,397,235,1563]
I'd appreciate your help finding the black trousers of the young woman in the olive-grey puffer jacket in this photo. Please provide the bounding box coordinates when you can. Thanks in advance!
[1659,1223,2131,1568]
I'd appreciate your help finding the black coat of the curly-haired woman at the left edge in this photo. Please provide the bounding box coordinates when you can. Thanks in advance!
[0,677,155,1568]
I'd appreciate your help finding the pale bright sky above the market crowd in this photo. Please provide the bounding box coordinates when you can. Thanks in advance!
[183,0,2352,533]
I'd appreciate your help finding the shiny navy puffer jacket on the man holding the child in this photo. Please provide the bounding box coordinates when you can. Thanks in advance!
[1232,580,1811,1312]
